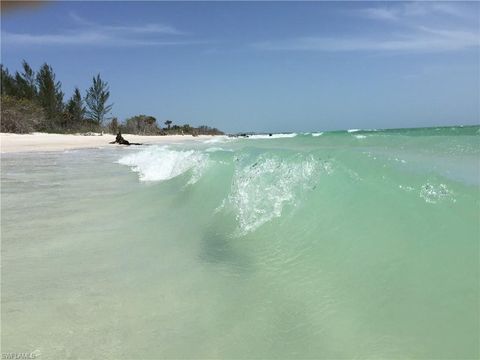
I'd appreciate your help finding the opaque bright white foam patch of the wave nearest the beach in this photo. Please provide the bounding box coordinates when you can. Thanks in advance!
[118,146,208,184]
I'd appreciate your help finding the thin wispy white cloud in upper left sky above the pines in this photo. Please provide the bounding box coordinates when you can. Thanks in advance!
[2,13,195,47]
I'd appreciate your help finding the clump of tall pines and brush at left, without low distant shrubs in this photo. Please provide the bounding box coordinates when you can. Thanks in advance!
[0,61,112,133]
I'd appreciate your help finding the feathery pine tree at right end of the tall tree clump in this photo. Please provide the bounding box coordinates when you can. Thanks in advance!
[85,74,112,125]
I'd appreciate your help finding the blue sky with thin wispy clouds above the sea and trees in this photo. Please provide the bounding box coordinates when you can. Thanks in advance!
[1,1,480,133]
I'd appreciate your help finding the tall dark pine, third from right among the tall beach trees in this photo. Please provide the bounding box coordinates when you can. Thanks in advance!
[37,64,63,123]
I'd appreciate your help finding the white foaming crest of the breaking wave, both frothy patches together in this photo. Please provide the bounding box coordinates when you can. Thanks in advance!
[118,146,333,235]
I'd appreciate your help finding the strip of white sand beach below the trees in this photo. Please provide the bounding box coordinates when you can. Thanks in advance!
[0,133,211,153]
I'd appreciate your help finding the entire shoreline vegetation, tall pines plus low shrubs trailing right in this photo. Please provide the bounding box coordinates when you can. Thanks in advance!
[0,60,222,135]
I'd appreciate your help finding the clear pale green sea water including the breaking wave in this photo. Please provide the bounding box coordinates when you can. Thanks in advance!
[1,127,480,359]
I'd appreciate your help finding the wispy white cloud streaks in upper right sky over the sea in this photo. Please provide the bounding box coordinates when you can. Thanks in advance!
[251,3,480,52]
